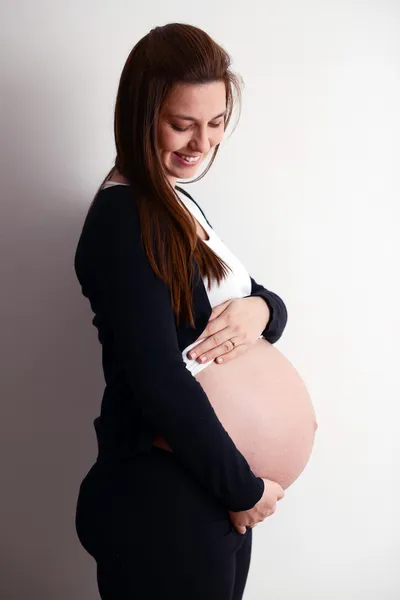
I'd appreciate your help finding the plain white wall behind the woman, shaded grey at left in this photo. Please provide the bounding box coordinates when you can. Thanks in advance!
[0,0,400,600]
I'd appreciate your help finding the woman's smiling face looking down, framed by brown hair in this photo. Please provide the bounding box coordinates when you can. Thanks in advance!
[158,81,226,187]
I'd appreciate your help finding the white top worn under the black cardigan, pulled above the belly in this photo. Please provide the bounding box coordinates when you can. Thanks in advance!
[103,181,262,375]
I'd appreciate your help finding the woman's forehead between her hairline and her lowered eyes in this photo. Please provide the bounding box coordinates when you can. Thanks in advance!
[163,81,226,120]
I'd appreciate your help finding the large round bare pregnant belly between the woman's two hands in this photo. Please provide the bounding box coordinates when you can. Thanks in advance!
[154,338,317,488]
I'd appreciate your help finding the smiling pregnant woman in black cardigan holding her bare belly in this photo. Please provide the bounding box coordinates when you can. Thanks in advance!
[75,23,315,600]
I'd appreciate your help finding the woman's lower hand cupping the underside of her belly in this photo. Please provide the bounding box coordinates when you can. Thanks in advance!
[228,477,285,534]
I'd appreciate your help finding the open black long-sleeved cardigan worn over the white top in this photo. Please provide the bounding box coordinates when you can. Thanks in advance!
[74,185,287,511]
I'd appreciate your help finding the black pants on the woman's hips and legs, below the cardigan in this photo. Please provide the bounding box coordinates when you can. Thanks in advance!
[76,446,252,600]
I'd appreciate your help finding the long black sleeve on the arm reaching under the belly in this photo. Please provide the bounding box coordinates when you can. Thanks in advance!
[81,187,264,511]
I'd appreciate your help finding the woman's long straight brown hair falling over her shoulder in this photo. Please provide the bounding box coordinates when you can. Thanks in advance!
[96,23,241,327]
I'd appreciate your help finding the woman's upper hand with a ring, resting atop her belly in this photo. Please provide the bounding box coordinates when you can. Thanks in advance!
[188,296,270,363]
